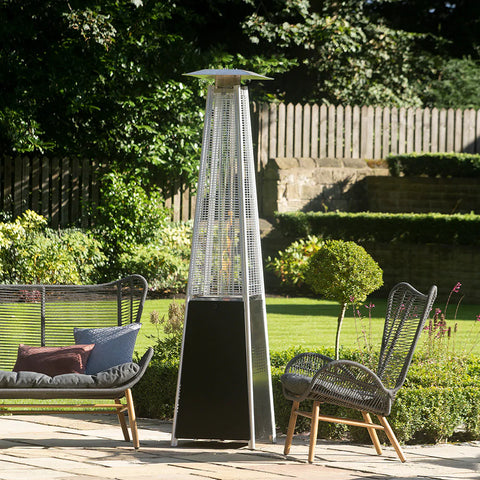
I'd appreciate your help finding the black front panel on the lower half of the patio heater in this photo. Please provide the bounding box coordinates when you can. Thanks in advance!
[173,299,250,440]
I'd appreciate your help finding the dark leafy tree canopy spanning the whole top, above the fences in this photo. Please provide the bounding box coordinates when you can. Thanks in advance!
[0,0,480,191]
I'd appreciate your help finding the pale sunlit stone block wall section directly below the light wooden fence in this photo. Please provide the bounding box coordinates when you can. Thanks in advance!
[260,158,388,218]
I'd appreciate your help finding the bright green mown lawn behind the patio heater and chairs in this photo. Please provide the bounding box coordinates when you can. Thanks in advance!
[137,297,480,355]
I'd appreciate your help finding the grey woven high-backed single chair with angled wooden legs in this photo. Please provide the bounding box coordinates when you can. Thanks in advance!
[281,282,437,463]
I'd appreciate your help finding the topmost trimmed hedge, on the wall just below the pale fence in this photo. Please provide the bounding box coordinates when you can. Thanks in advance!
[387,153,480,177]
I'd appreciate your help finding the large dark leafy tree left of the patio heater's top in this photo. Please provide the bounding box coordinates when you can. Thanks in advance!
[0,0,206,191]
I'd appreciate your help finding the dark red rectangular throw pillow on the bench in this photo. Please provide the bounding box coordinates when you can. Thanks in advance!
[13,344,95,377]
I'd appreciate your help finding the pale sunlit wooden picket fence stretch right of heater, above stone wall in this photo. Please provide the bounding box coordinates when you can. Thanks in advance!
[258,103,480,168]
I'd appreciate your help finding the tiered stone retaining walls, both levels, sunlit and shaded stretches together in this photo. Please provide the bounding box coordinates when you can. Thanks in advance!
[262,158,480,303]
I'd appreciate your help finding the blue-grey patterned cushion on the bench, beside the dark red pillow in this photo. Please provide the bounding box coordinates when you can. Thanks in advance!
[73,323,142,375]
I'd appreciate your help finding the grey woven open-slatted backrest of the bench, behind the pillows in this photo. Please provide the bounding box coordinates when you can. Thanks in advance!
[0,275,147,370]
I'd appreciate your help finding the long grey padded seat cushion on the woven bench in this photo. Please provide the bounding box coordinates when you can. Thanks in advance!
[0,362,140,389]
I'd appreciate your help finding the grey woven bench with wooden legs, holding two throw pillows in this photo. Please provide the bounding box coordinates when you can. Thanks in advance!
[0,275,153,448]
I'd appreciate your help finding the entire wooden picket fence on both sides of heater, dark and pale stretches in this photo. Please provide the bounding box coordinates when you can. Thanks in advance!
[0,104,480,228]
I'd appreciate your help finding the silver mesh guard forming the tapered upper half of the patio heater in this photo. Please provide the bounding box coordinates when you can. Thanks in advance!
[188,87,263,297]
